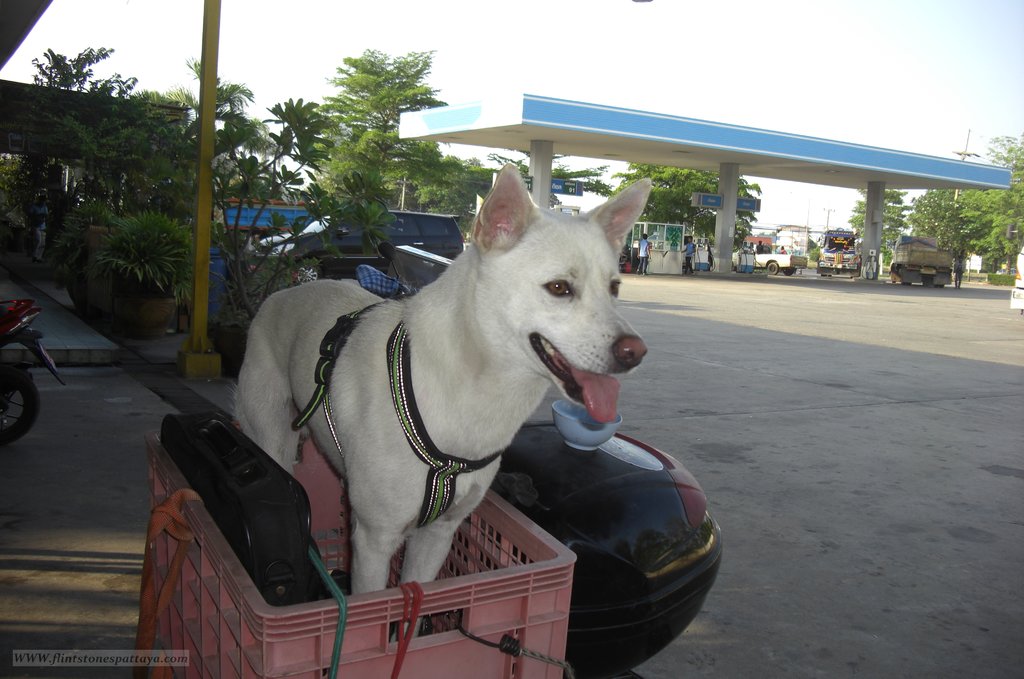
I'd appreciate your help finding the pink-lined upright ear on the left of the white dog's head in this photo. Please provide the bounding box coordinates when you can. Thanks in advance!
[473,163,537,251]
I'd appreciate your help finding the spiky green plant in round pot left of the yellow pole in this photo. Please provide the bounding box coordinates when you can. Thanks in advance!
[91,211,191,339]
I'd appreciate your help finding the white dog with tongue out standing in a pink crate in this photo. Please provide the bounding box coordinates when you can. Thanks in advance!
[237,166,650,593]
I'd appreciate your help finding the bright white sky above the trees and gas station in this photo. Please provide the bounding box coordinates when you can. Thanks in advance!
[0,0,1024,227]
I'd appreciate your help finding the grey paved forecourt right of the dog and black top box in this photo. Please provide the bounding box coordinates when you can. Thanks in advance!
[606,275,1024,679]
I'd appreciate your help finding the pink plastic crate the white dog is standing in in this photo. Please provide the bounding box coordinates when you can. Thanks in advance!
[145,433,575,679]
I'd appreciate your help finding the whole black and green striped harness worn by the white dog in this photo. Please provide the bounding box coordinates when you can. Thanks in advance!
[292,305,502,527]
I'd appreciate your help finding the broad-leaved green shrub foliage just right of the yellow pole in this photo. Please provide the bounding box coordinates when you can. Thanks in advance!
[213,99,393,326]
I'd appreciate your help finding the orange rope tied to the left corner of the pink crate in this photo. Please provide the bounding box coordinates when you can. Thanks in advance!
[132,489,202,679]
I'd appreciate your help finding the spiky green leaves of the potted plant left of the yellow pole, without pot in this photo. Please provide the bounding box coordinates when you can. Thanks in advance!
[93,211,193,301]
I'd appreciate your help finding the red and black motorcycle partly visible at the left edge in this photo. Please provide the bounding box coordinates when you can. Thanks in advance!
[0,299,65,445]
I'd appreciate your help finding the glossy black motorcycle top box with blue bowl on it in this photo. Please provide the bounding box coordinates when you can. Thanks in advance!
[496,424,722,678]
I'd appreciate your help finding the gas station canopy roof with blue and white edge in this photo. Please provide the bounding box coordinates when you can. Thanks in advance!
[400,94,1010,189]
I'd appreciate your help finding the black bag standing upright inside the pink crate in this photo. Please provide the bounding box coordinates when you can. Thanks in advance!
[160,413,322,605]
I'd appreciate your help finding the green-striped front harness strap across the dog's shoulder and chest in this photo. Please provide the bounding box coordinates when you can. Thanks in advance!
[387,323,502,526]
